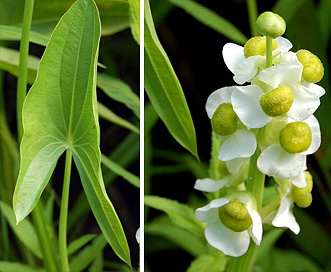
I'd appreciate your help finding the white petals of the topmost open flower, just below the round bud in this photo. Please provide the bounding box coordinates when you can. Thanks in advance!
[222,37,292,85]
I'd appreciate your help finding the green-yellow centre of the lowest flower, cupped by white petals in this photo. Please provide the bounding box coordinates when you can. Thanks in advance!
[218,201,252,232]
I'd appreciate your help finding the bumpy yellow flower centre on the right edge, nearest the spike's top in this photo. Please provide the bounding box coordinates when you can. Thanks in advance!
[296,49,324,83]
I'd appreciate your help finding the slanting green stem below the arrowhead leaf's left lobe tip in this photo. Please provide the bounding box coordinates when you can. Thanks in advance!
[31,202,58,271]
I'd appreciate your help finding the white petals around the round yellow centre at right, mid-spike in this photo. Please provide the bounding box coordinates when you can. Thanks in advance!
[257,115,321,179]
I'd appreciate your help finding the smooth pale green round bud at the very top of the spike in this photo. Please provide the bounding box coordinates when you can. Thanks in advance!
[256,11,286,39]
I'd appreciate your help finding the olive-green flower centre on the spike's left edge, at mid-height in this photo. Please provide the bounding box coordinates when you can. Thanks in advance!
[211,103,238,136]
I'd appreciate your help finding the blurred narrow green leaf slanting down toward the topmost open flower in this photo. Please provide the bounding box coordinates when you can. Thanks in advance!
[168,0,248,44]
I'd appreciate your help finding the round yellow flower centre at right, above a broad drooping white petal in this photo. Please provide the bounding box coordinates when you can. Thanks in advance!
[279,122,312,153]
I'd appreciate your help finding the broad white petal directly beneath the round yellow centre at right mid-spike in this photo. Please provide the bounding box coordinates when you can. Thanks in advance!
[257,144,306,179]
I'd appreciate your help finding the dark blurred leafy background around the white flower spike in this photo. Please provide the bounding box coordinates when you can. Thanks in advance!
[145,0,331,271]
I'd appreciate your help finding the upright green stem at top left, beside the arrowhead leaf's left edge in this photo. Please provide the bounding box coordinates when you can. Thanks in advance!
[16,0,34,142]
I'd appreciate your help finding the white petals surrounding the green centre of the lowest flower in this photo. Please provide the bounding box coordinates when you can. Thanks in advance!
[196,192,262,257]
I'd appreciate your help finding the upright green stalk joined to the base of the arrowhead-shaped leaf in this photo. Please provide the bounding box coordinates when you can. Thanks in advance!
[59,148,72,272]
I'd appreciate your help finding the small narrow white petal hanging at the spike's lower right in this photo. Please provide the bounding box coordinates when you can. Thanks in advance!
[272,195,300,234]
